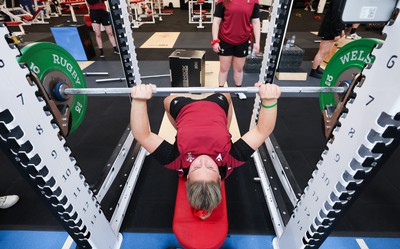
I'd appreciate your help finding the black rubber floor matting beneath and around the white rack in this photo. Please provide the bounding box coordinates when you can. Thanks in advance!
[0,97,400,236]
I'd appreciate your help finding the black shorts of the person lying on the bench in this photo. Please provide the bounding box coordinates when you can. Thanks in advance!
[169,93,229,119]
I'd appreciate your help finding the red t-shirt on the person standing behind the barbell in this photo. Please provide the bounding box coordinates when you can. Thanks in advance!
[214,0,260,45]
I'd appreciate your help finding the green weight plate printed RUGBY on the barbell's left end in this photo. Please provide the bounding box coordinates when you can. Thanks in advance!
[18,42,87,133]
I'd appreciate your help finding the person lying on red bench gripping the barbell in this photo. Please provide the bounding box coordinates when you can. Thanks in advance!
[131,83,281,219]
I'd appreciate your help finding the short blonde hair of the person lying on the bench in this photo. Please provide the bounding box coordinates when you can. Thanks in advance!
[186,179,222,212]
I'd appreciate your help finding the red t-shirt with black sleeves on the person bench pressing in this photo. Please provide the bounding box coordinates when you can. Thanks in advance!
[153,100,254,178]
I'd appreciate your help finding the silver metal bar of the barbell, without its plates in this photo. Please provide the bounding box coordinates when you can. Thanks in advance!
[60,85,347,97]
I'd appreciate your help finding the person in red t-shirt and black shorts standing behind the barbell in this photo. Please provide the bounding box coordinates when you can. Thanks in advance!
[211,0,261,99]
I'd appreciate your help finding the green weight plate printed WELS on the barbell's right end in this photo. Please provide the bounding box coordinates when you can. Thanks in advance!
[319,38,383,111]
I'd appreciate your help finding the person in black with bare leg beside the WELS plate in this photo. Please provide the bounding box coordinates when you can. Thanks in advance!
[309,0,345,79]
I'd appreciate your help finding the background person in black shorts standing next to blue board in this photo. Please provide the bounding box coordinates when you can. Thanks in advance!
[87,0,119,58]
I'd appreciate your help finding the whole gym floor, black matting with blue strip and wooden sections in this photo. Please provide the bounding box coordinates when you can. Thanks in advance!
[0,2,400,249]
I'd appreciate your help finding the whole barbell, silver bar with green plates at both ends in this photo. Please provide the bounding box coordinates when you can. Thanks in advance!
[18,39,380,136]
